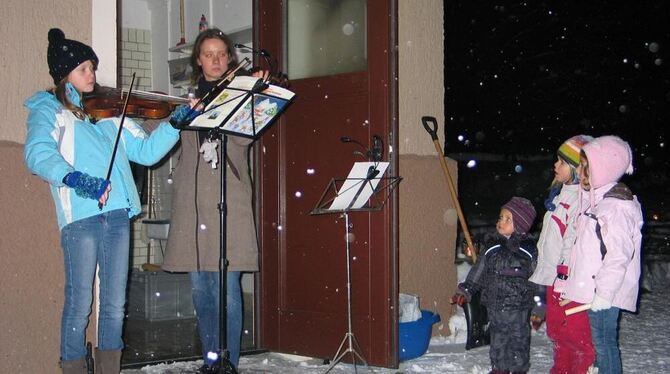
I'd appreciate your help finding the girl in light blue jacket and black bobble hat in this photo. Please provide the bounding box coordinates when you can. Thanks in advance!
[24,28,188,373]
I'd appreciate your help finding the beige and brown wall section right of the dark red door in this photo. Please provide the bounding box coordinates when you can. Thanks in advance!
[398,0,458,335]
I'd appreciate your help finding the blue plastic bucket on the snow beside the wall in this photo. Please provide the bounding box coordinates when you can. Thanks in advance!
[398,310,440,361]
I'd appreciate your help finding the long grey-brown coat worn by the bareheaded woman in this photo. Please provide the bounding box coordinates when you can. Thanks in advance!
[162,131,258,272]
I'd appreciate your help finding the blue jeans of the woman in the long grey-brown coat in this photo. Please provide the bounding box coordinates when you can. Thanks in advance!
[190,271,243,367]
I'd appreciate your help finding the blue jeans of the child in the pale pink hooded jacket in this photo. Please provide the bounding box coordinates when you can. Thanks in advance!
[589,307,622,374]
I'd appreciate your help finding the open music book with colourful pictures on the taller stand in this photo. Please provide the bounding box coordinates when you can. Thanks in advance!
[189,76,295,138]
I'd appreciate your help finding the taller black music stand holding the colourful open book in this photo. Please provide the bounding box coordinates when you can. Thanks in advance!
[176,76,295,374]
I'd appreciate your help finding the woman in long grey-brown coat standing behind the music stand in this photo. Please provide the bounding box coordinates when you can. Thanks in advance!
[162,28,268,373]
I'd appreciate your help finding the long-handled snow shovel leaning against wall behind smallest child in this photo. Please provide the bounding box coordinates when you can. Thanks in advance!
[421,116,489,350]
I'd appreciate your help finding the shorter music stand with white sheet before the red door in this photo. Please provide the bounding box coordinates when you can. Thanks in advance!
[310,162,402,373]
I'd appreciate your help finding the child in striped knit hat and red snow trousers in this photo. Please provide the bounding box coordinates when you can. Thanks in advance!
[530,135,596,374]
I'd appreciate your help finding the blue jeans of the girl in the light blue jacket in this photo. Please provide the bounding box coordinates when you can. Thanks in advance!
[60,209,130,361]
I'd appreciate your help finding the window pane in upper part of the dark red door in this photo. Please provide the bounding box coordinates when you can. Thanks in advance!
[286,0,368,79]
